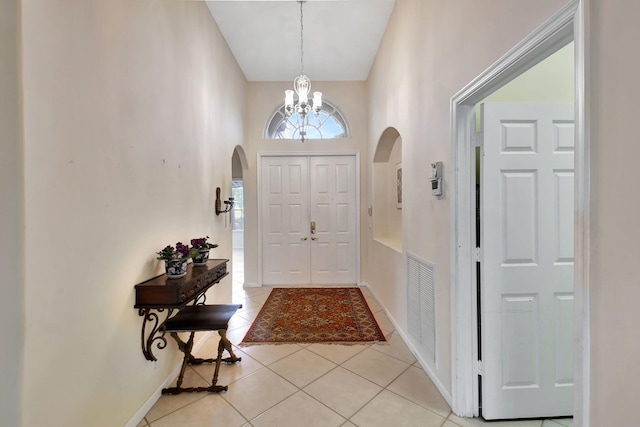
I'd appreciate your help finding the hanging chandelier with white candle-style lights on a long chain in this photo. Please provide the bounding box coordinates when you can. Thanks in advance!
[284,0,322,142]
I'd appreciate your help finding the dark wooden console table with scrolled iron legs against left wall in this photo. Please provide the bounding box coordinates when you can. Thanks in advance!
[134,259,229,361]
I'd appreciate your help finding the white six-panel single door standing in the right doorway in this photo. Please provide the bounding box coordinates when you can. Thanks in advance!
[480,103,574,419]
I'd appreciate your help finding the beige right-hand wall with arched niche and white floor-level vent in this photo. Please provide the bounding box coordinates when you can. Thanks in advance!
[366,0,576,397]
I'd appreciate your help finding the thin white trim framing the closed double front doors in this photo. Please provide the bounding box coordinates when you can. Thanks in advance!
[256,151,362,286]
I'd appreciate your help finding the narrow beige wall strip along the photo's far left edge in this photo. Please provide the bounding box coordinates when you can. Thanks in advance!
[0,0,24,426]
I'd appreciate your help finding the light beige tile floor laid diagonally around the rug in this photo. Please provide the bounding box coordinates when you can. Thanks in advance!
[138,254,573,427]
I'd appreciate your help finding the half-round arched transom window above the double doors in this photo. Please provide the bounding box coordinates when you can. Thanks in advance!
[265,100,351,140]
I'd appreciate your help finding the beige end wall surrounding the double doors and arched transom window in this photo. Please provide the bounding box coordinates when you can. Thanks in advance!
[244,80,368,286]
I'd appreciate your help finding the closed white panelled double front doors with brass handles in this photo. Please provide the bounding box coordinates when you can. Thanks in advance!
[260,156,358,285]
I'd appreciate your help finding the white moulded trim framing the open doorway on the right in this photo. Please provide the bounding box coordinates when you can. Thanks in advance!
[450,0,590,427]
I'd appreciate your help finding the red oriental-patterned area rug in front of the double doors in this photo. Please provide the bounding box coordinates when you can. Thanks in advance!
[242,288,386,345]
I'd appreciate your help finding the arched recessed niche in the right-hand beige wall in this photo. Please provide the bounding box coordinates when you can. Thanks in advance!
[372,127,402,252]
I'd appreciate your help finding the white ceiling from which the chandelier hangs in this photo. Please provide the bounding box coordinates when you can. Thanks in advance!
[206,0,395,81]
